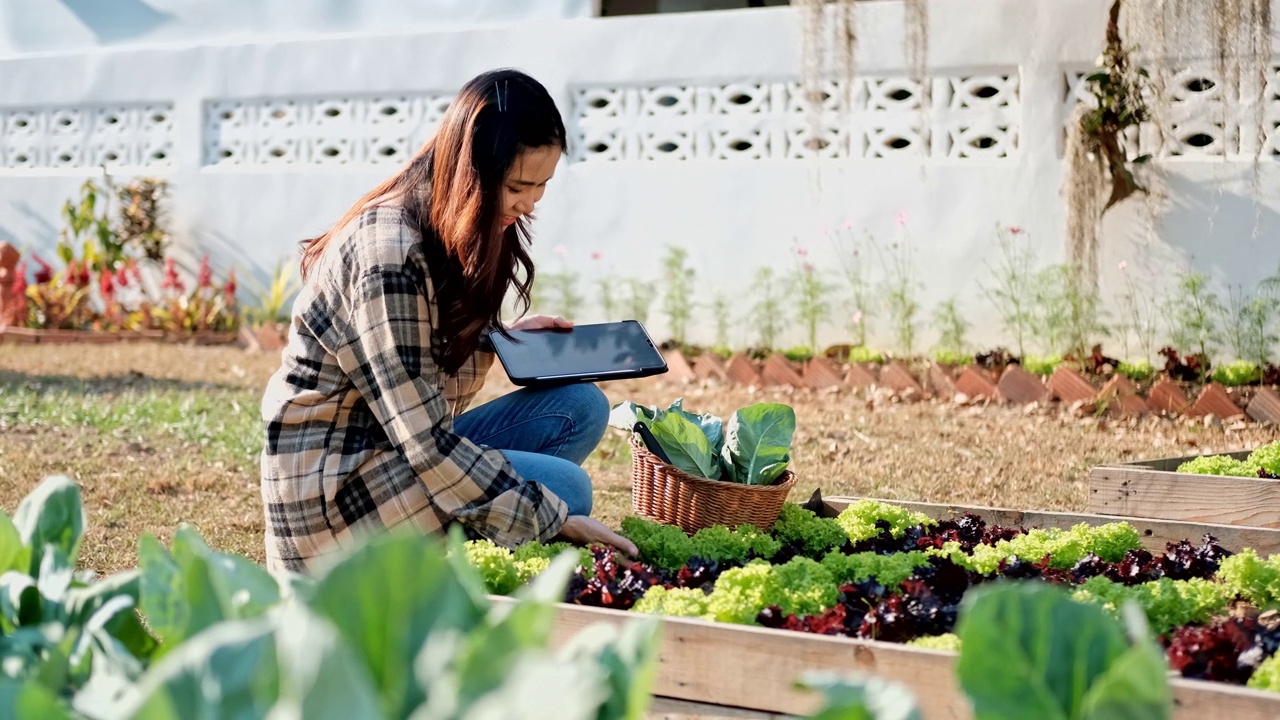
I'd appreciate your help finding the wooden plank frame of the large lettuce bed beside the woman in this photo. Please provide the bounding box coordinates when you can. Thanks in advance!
[499,497,1280,720]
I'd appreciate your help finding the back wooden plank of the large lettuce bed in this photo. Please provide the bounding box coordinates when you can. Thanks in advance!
[823,496,1280,555]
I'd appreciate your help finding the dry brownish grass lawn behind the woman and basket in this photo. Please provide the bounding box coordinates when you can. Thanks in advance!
[0,345,1280,571]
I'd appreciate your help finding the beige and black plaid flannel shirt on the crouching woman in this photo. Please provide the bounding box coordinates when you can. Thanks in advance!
[262,206,567,571]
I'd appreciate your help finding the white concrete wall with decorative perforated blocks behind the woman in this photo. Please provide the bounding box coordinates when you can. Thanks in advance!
[0,0,1280,347]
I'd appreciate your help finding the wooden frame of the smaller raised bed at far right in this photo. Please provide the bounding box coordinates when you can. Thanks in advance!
[1088,451,1280,527]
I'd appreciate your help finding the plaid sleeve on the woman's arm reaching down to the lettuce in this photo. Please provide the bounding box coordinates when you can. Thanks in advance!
[338,265,568,547]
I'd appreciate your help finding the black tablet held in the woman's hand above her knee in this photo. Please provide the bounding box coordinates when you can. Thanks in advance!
[489,320,667,386]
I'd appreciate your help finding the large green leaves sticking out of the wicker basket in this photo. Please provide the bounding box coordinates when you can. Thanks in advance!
[609,398,796,486]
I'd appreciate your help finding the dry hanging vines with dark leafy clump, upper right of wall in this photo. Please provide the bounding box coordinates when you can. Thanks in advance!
[1064,0,1272,284]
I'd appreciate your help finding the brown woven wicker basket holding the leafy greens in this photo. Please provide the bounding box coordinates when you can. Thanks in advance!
[631,438,796,533]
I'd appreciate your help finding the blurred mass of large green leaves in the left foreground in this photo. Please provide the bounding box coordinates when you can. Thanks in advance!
[0,478,657,720]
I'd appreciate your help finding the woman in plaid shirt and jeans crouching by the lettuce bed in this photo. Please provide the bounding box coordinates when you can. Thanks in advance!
[262,70,636,570]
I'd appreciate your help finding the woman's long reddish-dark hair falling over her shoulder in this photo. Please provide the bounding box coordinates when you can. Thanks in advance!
[301,69,566,373]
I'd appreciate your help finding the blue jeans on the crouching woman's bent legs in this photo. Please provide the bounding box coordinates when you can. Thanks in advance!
[453,384,609,515]
